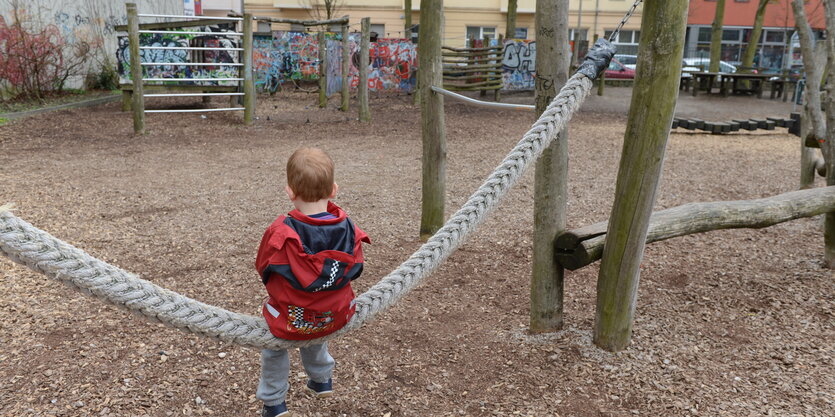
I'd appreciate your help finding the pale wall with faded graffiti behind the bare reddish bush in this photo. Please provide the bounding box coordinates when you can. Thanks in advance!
[0,0,183,87]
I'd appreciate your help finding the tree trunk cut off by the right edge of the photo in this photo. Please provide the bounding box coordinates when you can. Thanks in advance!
[821,1,835,269]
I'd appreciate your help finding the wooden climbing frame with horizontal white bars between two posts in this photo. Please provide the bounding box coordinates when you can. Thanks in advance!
[116,3,255,133]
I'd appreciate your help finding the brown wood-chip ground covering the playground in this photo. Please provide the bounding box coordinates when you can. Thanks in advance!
[0,88,835,417]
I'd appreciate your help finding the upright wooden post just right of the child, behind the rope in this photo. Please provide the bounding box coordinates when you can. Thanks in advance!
[418,0,446,240]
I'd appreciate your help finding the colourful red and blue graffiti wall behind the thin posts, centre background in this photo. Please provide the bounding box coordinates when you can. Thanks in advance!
[253,31,417,95]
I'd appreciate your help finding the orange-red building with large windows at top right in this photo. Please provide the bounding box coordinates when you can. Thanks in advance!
[684,0,826,71]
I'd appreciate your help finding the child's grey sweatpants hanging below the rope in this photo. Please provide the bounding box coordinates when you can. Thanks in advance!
[255,342,335,406]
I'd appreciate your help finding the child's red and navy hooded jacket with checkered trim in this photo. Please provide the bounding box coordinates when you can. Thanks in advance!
[255,202,370,340]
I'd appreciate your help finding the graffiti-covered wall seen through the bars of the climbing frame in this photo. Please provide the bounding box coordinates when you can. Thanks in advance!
[116,23,240,85]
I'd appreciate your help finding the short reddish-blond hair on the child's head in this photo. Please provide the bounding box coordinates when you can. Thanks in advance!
[287,148,333,202]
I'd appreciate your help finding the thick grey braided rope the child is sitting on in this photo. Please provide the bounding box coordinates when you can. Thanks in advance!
[0,73,592,349]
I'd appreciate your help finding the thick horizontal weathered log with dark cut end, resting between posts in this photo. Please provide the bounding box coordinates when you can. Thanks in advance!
[554,186,835,270]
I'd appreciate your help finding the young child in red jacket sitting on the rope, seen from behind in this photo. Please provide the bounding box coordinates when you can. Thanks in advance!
[255,148,370,417]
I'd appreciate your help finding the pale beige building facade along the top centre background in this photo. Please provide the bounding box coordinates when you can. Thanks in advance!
[238,0,641,48]
